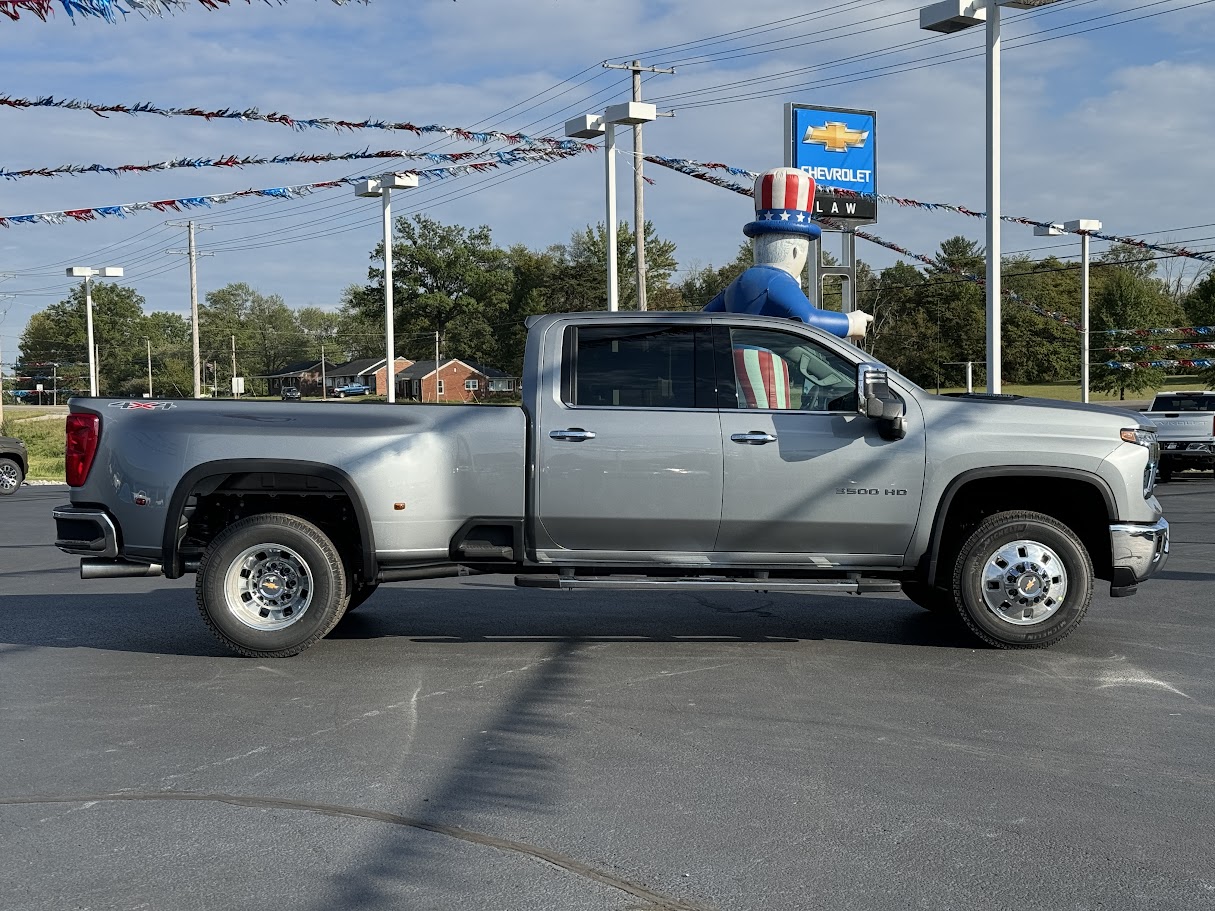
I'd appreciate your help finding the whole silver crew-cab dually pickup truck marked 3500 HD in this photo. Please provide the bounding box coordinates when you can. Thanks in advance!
[55,312,1169,657]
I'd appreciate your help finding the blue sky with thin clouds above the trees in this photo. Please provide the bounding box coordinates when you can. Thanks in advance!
[0,0,1215,364]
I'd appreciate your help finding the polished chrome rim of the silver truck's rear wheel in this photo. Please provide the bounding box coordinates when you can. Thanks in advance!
[224,544,313,632]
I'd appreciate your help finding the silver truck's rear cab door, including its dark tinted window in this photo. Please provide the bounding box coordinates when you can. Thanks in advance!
[533,321,722,562]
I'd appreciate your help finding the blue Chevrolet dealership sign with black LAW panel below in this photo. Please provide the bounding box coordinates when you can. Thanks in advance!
[785,104,877,223]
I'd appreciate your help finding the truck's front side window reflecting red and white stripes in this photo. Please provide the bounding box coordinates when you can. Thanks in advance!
[730,328,857,412]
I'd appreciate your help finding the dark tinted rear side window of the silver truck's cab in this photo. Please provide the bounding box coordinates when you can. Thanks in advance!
[561,326,716,408]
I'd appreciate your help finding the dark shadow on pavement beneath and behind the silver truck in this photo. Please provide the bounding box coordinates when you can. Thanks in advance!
[0,585,983,658]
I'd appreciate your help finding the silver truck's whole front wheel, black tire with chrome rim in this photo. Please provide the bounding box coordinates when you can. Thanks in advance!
[954,511,1094,649]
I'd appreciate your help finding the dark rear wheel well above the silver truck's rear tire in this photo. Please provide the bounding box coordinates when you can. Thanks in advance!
[164,470,377,584]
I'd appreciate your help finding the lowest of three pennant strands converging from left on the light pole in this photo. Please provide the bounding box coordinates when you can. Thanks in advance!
[0,149,588,227]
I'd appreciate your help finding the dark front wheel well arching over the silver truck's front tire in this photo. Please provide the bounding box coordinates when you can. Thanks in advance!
[927,474,1113,584]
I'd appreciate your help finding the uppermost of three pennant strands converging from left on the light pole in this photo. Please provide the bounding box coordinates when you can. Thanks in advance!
[0,92,582,148]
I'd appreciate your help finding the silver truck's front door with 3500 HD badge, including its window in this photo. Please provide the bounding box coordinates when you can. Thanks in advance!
[714,326,925,565]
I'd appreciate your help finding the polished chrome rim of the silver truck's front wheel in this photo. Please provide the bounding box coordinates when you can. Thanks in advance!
[983,541,1067,627]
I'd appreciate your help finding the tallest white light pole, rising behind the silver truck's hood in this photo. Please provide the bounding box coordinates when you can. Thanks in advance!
[920,0,1058,395]
